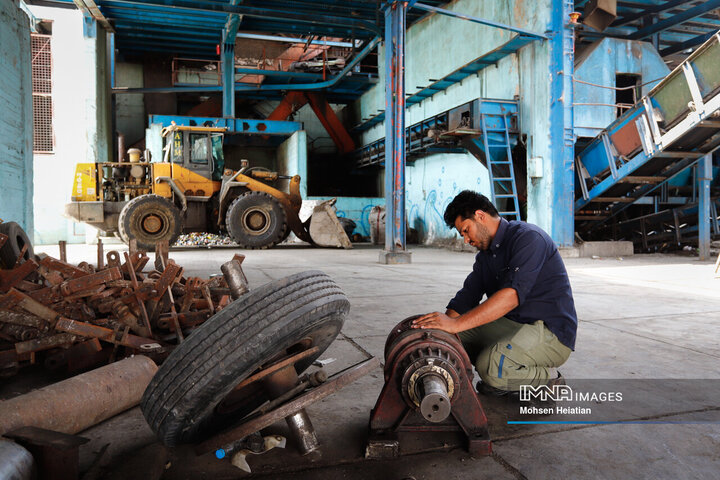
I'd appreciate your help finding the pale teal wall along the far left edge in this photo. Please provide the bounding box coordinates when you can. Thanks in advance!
[0,1,33,238]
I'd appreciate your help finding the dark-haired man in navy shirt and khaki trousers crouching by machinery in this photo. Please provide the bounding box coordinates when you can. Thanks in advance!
[413,190,577,395]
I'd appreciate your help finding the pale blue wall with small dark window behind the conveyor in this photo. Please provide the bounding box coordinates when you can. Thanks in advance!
[574,38,670,138]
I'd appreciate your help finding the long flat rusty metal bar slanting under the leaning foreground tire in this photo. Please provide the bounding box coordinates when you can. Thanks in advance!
[195,357,380,454]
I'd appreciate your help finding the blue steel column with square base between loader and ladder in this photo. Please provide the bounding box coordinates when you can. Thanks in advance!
[380,1,410,263]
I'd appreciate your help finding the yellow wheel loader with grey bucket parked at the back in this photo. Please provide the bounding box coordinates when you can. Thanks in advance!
[65,124,350,251]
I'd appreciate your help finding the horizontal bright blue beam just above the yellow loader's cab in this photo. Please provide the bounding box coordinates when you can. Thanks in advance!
[148,115,302,137]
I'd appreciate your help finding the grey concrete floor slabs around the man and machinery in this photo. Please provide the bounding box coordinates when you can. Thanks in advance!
[8,246,720,480]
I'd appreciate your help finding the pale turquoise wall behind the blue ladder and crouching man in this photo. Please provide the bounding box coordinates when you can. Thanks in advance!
[355,0,553,244]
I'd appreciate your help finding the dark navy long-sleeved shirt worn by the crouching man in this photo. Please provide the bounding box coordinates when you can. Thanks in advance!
[447,218,577,350]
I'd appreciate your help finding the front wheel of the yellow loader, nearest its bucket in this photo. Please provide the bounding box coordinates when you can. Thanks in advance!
[225,192,288,249]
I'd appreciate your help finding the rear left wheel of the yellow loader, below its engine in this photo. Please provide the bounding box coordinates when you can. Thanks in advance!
[118,194,182,252]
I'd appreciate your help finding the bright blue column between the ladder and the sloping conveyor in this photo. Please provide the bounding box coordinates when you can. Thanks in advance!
[549,0,575,247]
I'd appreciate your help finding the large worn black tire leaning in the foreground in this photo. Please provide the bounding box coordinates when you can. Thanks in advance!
[140,271,350,446]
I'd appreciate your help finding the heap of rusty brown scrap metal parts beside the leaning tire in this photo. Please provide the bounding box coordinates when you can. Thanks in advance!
[0,223,246,376]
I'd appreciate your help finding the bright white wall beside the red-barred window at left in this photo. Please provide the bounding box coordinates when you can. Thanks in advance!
[29,6,112,248]
